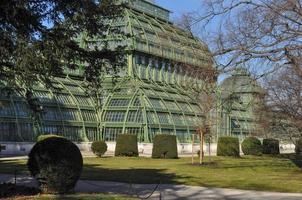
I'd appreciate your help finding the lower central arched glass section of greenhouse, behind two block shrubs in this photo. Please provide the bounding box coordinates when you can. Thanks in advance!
[101,81,202,142]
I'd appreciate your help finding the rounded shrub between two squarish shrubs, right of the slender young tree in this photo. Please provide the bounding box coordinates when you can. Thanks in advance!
[241,137,263,156]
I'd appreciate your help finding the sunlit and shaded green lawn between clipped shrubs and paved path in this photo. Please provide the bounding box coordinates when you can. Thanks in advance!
[0,155,302,192]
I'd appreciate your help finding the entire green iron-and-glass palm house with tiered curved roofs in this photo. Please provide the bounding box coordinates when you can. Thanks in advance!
[0,0,258,143]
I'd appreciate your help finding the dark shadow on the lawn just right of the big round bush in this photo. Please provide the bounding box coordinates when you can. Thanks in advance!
[81,163,190,184]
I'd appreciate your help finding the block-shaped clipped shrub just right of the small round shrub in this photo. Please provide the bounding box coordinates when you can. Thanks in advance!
[114,134,138,157]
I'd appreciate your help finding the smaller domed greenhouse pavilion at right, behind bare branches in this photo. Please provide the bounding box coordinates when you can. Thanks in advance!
[220,68,264,137]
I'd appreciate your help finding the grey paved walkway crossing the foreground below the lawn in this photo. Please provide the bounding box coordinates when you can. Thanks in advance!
[0,174,302,200]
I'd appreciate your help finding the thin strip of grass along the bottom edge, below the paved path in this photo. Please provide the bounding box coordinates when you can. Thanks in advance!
[5,194,134,200]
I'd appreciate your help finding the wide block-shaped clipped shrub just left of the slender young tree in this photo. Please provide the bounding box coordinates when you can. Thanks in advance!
[152,134,178,158]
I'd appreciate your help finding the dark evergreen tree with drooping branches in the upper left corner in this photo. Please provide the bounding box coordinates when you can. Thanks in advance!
[0,0,125,92]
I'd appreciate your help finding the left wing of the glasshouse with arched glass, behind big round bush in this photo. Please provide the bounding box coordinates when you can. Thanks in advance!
[0,78,100,142]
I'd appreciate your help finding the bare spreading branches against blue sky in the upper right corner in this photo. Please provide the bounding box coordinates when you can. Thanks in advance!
[191,0,302,72]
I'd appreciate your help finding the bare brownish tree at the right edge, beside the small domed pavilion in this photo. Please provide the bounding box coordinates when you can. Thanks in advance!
[266,65,302,141]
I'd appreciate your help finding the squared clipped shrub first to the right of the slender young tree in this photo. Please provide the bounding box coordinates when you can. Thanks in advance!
[217,136,240,157]
